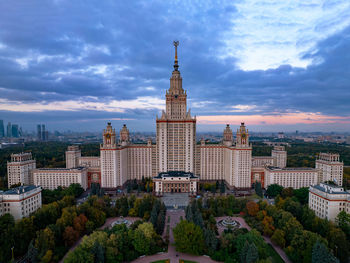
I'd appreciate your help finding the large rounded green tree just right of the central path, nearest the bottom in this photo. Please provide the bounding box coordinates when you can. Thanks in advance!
[173,220,205,255]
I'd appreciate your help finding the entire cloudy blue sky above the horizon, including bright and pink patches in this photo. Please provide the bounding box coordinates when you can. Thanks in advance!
[0,0,350,131]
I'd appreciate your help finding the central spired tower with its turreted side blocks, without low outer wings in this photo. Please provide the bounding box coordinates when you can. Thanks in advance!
[95,42,252,192]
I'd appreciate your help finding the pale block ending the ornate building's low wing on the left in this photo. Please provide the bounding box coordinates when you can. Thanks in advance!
[7,153,36,188]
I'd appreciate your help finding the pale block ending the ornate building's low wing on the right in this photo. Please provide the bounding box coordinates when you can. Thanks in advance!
[316,153,344,186]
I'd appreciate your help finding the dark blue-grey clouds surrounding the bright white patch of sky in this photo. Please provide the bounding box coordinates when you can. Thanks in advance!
[0,0,350,132]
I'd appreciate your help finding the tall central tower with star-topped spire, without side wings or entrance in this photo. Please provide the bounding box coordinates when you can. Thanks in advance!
[157,41,196,173]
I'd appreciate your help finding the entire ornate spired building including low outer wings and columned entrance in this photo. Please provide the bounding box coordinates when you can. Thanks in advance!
[8,42,343,195]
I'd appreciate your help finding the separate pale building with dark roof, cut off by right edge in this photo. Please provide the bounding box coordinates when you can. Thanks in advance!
[309,183,350,221]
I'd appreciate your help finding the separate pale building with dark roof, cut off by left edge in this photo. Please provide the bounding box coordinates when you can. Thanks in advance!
[0,185,42,220]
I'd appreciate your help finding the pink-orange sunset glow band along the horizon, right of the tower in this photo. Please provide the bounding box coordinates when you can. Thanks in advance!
[197,112,350,125]
